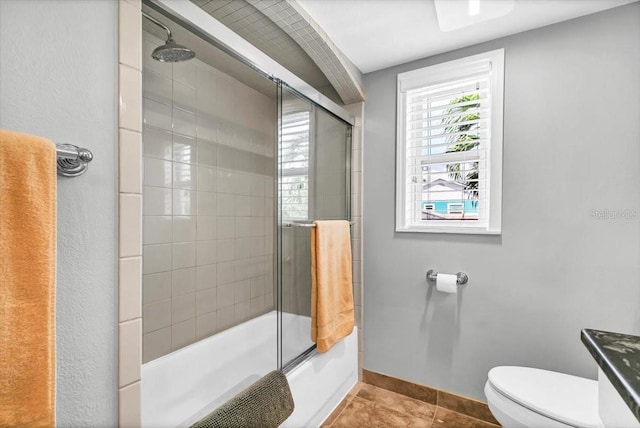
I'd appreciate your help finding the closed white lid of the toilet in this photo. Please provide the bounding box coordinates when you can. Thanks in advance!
[489,367,602,428]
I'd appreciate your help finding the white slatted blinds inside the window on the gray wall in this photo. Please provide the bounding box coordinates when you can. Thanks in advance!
[406,75,491,223]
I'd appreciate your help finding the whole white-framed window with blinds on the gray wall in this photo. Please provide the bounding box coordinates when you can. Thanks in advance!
[396,49,504,234]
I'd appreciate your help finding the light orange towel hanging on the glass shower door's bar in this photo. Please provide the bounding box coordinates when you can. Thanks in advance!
[311,220,354,352]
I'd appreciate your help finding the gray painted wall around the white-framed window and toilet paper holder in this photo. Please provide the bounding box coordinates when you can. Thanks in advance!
[364,3,640,400]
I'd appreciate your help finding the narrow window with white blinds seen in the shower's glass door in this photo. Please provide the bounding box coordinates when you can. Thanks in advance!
[280,111,310,220]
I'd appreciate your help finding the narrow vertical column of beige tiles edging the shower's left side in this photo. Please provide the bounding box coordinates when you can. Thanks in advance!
[118,0,142,428]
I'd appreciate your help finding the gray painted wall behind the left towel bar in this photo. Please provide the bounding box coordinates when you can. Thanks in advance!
[0,0,118,427]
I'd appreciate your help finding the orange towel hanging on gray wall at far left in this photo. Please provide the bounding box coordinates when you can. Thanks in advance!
[0,130,56,427]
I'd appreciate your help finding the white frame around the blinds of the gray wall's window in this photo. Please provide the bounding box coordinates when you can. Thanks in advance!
[395,49,504,235]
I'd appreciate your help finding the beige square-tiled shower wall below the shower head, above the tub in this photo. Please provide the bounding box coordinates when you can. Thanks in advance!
[142,32,276,362]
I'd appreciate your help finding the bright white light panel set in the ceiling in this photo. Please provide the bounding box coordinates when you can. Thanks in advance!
[434,0,515,32]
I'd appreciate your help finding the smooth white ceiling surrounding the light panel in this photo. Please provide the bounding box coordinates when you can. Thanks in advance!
[298,0,638,73]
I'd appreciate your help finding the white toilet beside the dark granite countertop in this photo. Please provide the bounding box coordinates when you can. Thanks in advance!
[484,366,604,428]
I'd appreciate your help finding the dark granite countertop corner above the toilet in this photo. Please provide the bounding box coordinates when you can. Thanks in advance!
[580,329,640,421]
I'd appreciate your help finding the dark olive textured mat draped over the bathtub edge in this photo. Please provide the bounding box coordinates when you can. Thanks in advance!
[191,370,294,428]
